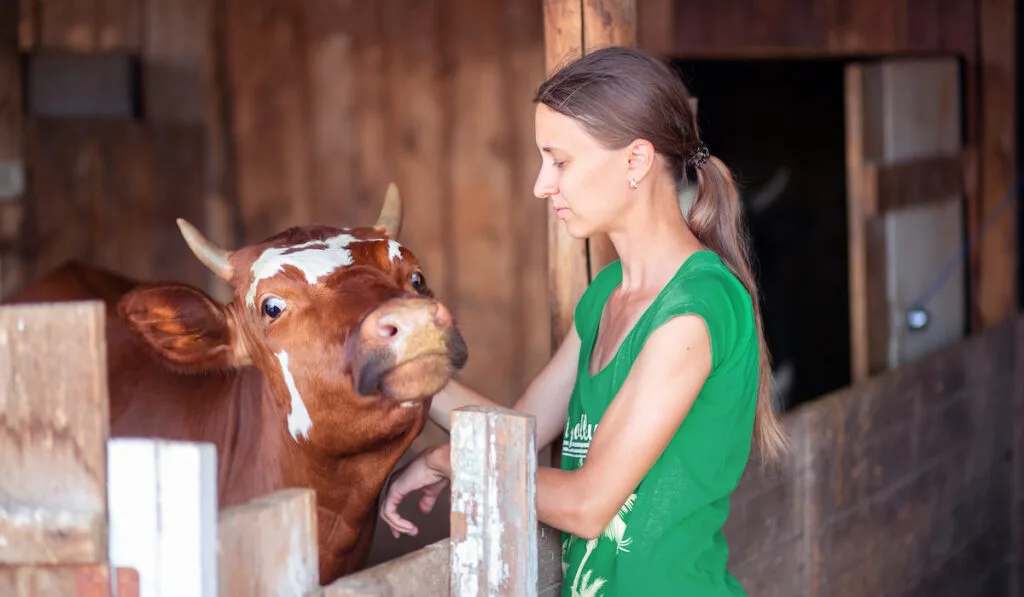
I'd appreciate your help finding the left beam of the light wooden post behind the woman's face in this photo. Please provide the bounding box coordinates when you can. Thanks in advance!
[544,0,589,347]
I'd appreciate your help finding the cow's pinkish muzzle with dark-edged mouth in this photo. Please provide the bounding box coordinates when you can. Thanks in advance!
[349,298,468,402]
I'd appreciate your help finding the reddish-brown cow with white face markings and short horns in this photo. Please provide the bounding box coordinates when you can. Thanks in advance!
[4,184,468,585]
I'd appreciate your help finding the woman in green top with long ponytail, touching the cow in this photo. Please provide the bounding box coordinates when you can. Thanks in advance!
[381,47,785,596]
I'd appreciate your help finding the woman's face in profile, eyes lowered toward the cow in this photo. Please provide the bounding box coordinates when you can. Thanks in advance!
[534,103,631,239]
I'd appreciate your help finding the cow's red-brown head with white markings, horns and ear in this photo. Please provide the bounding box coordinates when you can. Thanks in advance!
[119,185,466,453]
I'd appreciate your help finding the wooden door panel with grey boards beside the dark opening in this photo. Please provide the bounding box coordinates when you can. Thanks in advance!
[845,57,967,382]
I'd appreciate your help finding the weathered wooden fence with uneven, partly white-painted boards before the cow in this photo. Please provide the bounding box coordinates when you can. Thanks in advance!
[0,301,554,597]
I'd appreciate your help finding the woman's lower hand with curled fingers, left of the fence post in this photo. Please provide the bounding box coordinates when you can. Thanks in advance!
[380,443,452,539]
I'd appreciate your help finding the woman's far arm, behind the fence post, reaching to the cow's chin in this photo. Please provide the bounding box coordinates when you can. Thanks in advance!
[430,325,580,451]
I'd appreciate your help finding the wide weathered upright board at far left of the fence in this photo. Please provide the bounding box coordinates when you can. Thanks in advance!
[0,302,109,564]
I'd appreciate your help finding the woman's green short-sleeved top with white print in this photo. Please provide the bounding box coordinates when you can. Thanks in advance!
[561,250,758,597]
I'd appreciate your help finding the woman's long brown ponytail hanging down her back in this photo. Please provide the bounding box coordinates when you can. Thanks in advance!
[688,155,788,471]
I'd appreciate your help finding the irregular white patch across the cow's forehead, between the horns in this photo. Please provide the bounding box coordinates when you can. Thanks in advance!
[246,232,401,308]
